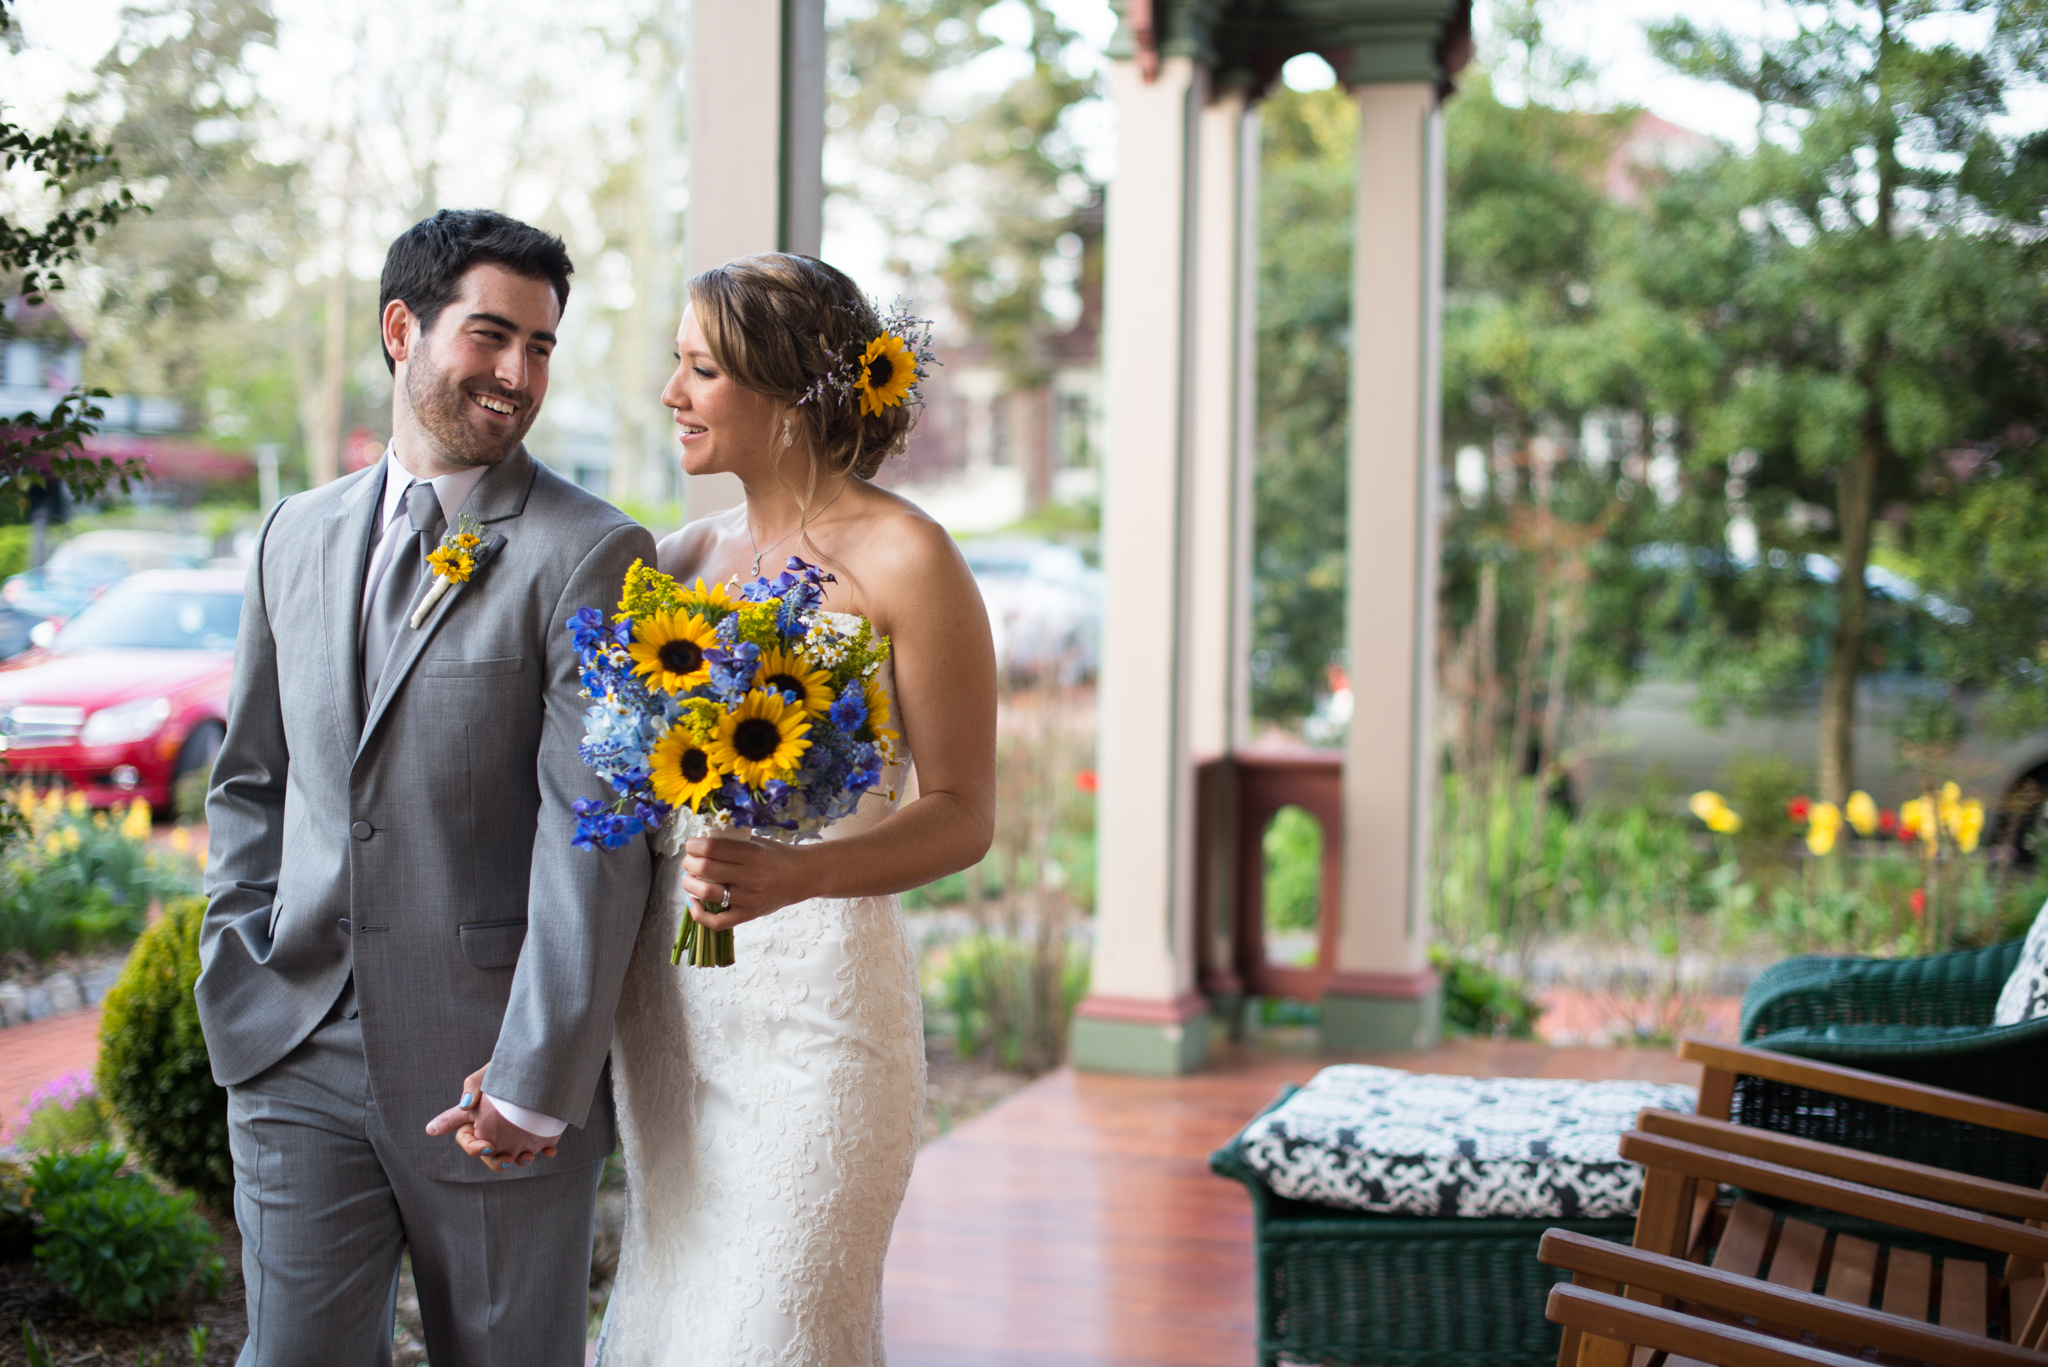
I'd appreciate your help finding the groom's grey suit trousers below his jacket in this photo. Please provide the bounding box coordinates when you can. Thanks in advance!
[227,1006,604,1367]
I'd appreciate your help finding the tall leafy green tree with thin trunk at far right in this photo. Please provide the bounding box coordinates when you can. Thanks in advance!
[1630,0,2048,786]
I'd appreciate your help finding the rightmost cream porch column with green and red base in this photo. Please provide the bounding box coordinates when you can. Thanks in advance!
[1323,74,1444,1049]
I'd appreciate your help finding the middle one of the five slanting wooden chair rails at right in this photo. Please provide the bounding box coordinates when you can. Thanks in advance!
[1620,1129,2048,1260]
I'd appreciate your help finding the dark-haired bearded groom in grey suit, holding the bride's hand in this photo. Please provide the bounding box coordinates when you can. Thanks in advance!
[197,211,653,1367]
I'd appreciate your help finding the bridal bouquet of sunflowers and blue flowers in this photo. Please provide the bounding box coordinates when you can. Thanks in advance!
[569,557,897,967]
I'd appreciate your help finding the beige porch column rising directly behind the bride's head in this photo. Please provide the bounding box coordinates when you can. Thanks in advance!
[678,0,825,519]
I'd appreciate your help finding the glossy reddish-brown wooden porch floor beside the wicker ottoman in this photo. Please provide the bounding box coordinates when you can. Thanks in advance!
[883,1041,1700,1367]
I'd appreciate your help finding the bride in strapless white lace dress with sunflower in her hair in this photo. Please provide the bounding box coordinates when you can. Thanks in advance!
[598,254,995,1367]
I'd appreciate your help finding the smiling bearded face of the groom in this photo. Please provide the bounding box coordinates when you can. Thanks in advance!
[393,264,561,469]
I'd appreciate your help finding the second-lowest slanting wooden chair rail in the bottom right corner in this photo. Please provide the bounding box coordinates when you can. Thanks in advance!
[1536,1230,2048,1367]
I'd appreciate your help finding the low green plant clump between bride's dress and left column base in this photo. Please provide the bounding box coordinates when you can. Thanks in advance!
[932,935,1087,1072]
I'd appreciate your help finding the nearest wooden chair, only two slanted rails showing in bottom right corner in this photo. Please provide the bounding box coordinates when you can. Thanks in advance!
[1538,1230,2044,1367]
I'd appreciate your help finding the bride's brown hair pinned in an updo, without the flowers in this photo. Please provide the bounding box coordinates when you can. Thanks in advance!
[690,252,915,480]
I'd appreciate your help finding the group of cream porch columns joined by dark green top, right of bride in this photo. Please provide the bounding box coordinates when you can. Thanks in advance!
[1071,0,1470,1074]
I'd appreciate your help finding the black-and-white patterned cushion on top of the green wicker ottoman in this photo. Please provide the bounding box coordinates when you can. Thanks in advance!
[1243,1064,1698,1219]
